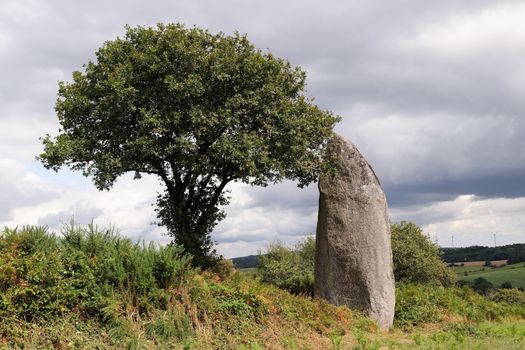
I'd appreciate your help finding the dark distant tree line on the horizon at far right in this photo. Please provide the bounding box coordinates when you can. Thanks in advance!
[442,244,525,264]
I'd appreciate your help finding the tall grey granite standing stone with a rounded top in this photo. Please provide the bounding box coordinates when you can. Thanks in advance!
[314,135,395,329]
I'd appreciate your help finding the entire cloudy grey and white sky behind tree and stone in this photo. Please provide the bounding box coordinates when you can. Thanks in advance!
[0,0,525,257]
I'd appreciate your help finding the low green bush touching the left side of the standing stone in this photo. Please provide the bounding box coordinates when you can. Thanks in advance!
[258,237,315,296]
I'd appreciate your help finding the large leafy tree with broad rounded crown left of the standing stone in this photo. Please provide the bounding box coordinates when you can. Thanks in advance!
[39,24,339,266]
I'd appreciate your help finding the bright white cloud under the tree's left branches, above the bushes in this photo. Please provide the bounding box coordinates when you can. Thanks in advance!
[4,174,165,242]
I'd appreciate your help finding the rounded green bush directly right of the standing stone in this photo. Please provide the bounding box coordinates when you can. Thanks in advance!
[391,221,456,287]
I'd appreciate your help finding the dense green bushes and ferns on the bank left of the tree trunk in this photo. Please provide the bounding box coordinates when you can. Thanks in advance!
[0,224,195,320]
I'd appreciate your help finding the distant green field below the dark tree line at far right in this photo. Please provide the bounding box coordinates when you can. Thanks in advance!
[452,263,525,288]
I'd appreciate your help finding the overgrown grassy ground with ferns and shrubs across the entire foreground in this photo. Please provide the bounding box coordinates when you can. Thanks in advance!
[0,226,525,350]
